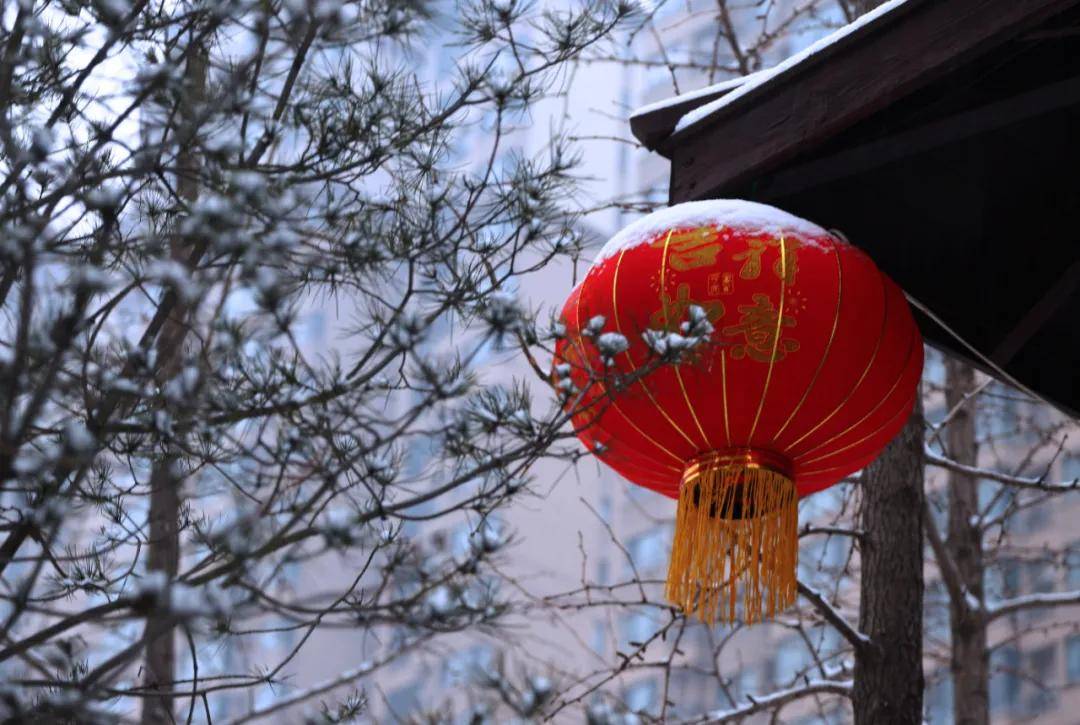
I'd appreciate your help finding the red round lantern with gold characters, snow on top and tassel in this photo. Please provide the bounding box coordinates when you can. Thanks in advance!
[554,201,922,622]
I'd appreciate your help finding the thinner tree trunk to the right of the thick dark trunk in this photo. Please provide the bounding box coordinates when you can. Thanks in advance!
[945,359,990,725]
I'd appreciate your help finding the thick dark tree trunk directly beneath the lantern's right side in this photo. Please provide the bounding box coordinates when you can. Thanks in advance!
[852,401,923,725]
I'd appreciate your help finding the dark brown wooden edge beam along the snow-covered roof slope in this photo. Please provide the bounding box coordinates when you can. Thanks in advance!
[667,0,1080,203]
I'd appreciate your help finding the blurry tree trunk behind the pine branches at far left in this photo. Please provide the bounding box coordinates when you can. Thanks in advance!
[141,49,207,725]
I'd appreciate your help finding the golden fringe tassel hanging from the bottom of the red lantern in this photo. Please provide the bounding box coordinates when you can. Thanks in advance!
[666,452,798,625]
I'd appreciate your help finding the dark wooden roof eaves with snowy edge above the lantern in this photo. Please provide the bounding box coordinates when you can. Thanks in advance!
[631,0,1080,416]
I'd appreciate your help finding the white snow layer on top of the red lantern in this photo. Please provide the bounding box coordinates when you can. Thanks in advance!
[593,199,832,265]
